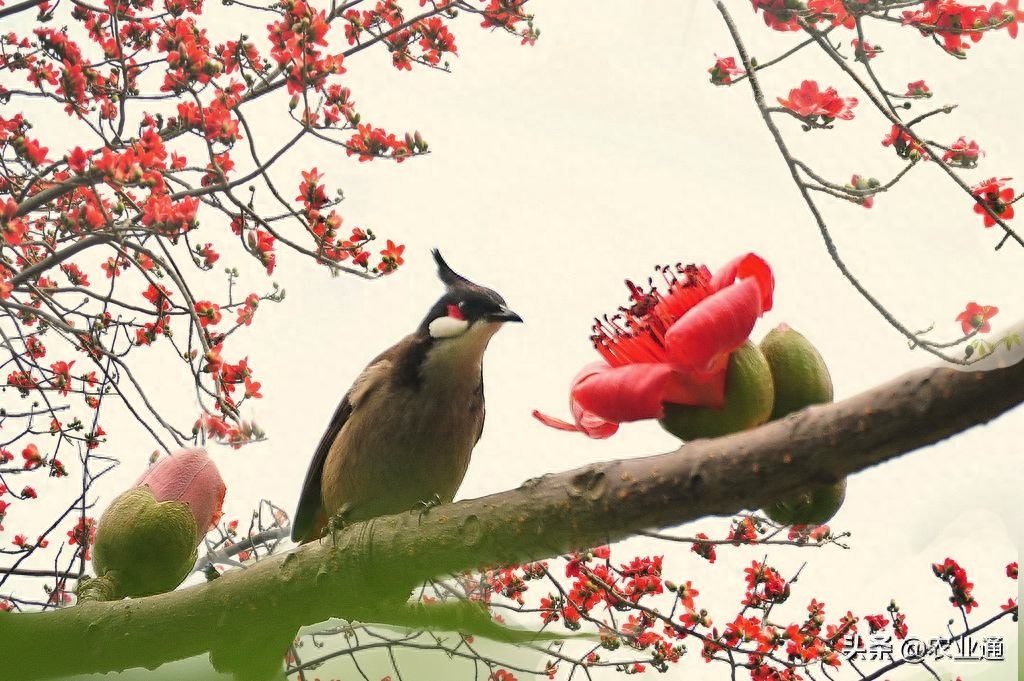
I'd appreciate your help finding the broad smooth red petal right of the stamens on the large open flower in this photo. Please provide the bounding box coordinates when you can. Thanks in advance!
[665,279,763,373]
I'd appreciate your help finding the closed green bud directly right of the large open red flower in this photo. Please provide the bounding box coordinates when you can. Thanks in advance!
[761,324,833,421]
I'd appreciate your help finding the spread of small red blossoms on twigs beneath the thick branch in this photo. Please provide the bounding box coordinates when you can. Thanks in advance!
[422,532,1017,681]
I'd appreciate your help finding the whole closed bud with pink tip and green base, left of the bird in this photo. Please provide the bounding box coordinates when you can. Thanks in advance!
[92,449,226,599]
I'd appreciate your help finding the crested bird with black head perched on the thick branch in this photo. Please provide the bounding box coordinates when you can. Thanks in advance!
[292,249,522,544]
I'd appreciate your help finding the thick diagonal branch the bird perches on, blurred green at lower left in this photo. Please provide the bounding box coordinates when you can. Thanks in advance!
[0,352,1024,681]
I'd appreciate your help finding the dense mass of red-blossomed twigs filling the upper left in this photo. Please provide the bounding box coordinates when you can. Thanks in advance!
[0,0,538,585]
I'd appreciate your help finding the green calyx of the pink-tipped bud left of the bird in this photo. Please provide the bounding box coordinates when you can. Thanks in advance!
[92,485,199,598]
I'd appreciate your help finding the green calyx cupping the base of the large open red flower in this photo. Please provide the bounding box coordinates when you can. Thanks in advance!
[658,341,774,440]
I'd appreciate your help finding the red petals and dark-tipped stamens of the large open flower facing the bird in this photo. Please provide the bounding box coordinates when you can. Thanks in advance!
[534,253,774,438]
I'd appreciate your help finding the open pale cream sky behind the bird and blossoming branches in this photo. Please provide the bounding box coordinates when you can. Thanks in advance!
[4,0,1024,680]
